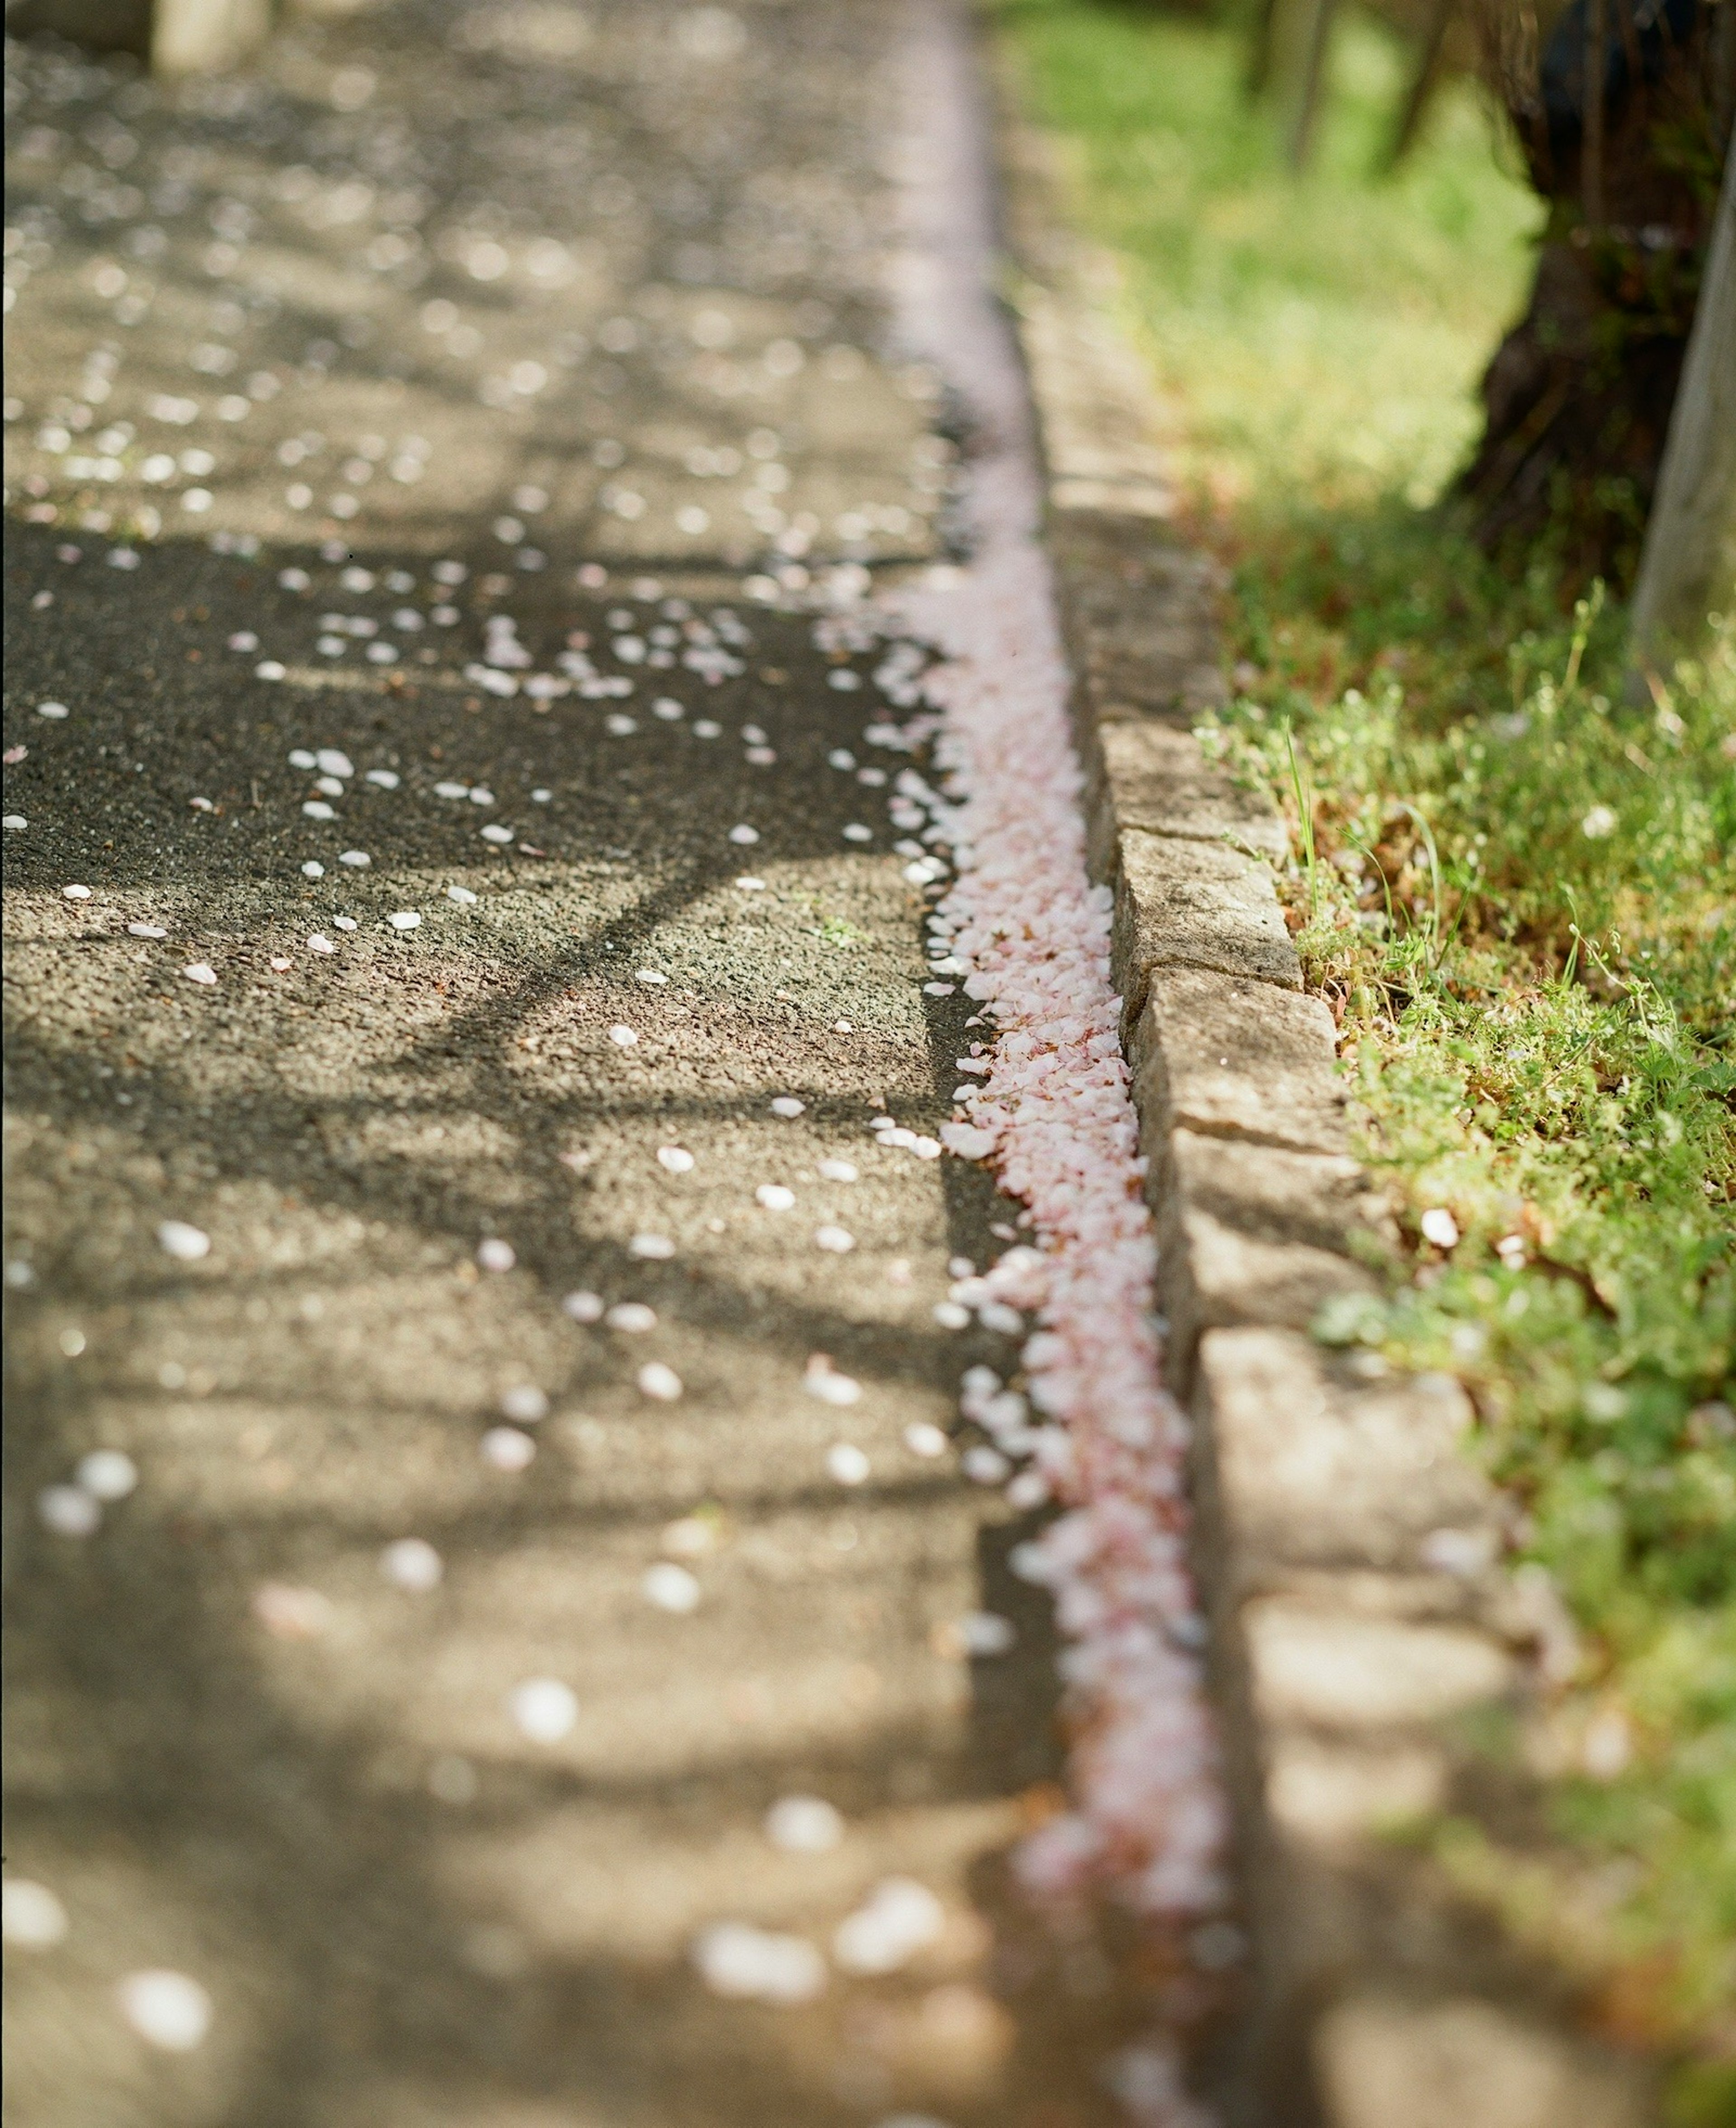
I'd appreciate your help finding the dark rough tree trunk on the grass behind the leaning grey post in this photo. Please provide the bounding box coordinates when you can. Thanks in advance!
[1462,0,1736,585]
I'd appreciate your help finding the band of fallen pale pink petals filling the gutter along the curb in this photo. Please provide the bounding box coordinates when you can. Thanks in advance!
[851,11,1227,2124]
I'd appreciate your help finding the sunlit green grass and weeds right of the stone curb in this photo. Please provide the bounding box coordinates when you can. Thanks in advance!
[998,0,1736,2094]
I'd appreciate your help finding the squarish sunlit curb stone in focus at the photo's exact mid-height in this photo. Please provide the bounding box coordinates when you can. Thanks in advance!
[1130,968,1347,1173]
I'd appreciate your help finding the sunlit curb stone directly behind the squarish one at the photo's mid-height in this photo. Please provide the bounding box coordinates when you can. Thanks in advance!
[1113,828,1302,1028]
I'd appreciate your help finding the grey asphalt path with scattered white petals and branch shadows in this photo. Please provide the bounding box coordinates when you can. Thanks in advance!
[6,0,1149,2128]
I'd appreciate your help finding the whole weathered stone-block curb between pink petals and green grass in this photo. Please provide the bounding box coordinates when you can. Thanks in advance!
[1000,98,1651,2128]
